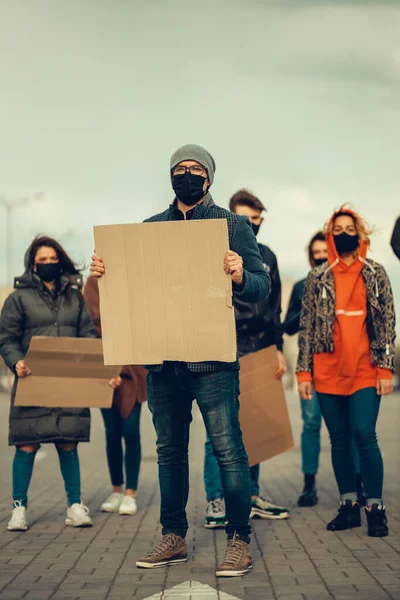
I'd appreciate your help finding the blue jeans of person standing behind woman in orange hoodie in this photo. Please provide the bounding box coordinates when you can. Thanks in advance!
[300,392,360,475]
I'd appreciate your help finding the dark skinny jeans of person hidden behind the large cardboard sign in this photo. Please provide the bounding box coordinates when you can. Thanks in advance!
[101,402,142,490]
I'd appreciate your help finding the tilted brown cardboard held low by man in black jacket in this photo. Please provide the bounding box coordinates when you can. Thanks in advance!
[240,346,294,466]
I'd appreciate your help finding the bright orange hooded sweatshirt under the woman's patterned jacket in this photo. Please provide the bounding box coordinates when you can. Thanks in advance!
[297,211,392,396]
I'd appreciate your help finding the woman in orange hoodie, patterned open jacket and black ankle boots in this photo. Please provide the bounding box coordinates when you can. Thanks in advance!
[297,206,396,537]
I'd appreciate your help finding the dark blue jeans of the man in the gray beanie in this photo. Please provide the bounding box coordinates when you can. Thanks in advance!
[147,363,251,539]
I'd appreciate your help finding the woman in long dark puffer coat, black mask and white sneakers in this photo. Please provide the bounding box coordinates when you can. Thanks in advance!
[0,236,96,531]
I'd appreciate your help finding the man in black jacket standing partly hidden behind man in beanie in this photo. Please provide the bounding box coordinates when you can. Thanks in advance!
[204,190,289,529]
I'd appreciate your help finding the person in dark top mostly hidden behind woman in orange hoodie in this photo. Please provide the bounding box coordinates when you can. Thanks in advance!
[283,231,365,506]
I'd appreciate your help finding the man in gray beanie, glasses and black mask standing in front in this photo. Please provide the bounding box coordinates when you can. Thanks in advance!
[91,144,270,577]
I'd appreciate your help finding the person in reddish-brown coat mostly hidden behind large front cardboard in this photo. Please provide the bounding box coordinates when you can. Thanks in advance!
[84,277,147,515]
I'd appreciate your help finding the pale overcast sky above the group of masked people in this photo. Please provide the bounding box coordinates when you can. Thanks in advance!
[0,0,400,322]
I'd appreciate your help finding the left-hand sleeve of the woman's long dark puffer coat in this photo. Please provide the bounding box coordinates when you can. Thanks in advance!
[0,293,25,371]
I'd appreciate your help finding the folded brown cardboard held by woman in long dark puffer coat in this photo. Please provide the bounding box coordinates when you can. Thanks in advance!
[15,337,121,408]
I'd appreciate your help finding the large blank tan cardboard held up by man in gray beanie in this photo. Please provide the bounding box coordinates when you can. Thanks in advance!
[94,219,236,365]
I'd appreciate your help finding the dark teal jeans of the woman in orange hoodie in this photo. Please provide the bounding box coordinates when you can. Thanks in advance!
[317,387,383,499]
